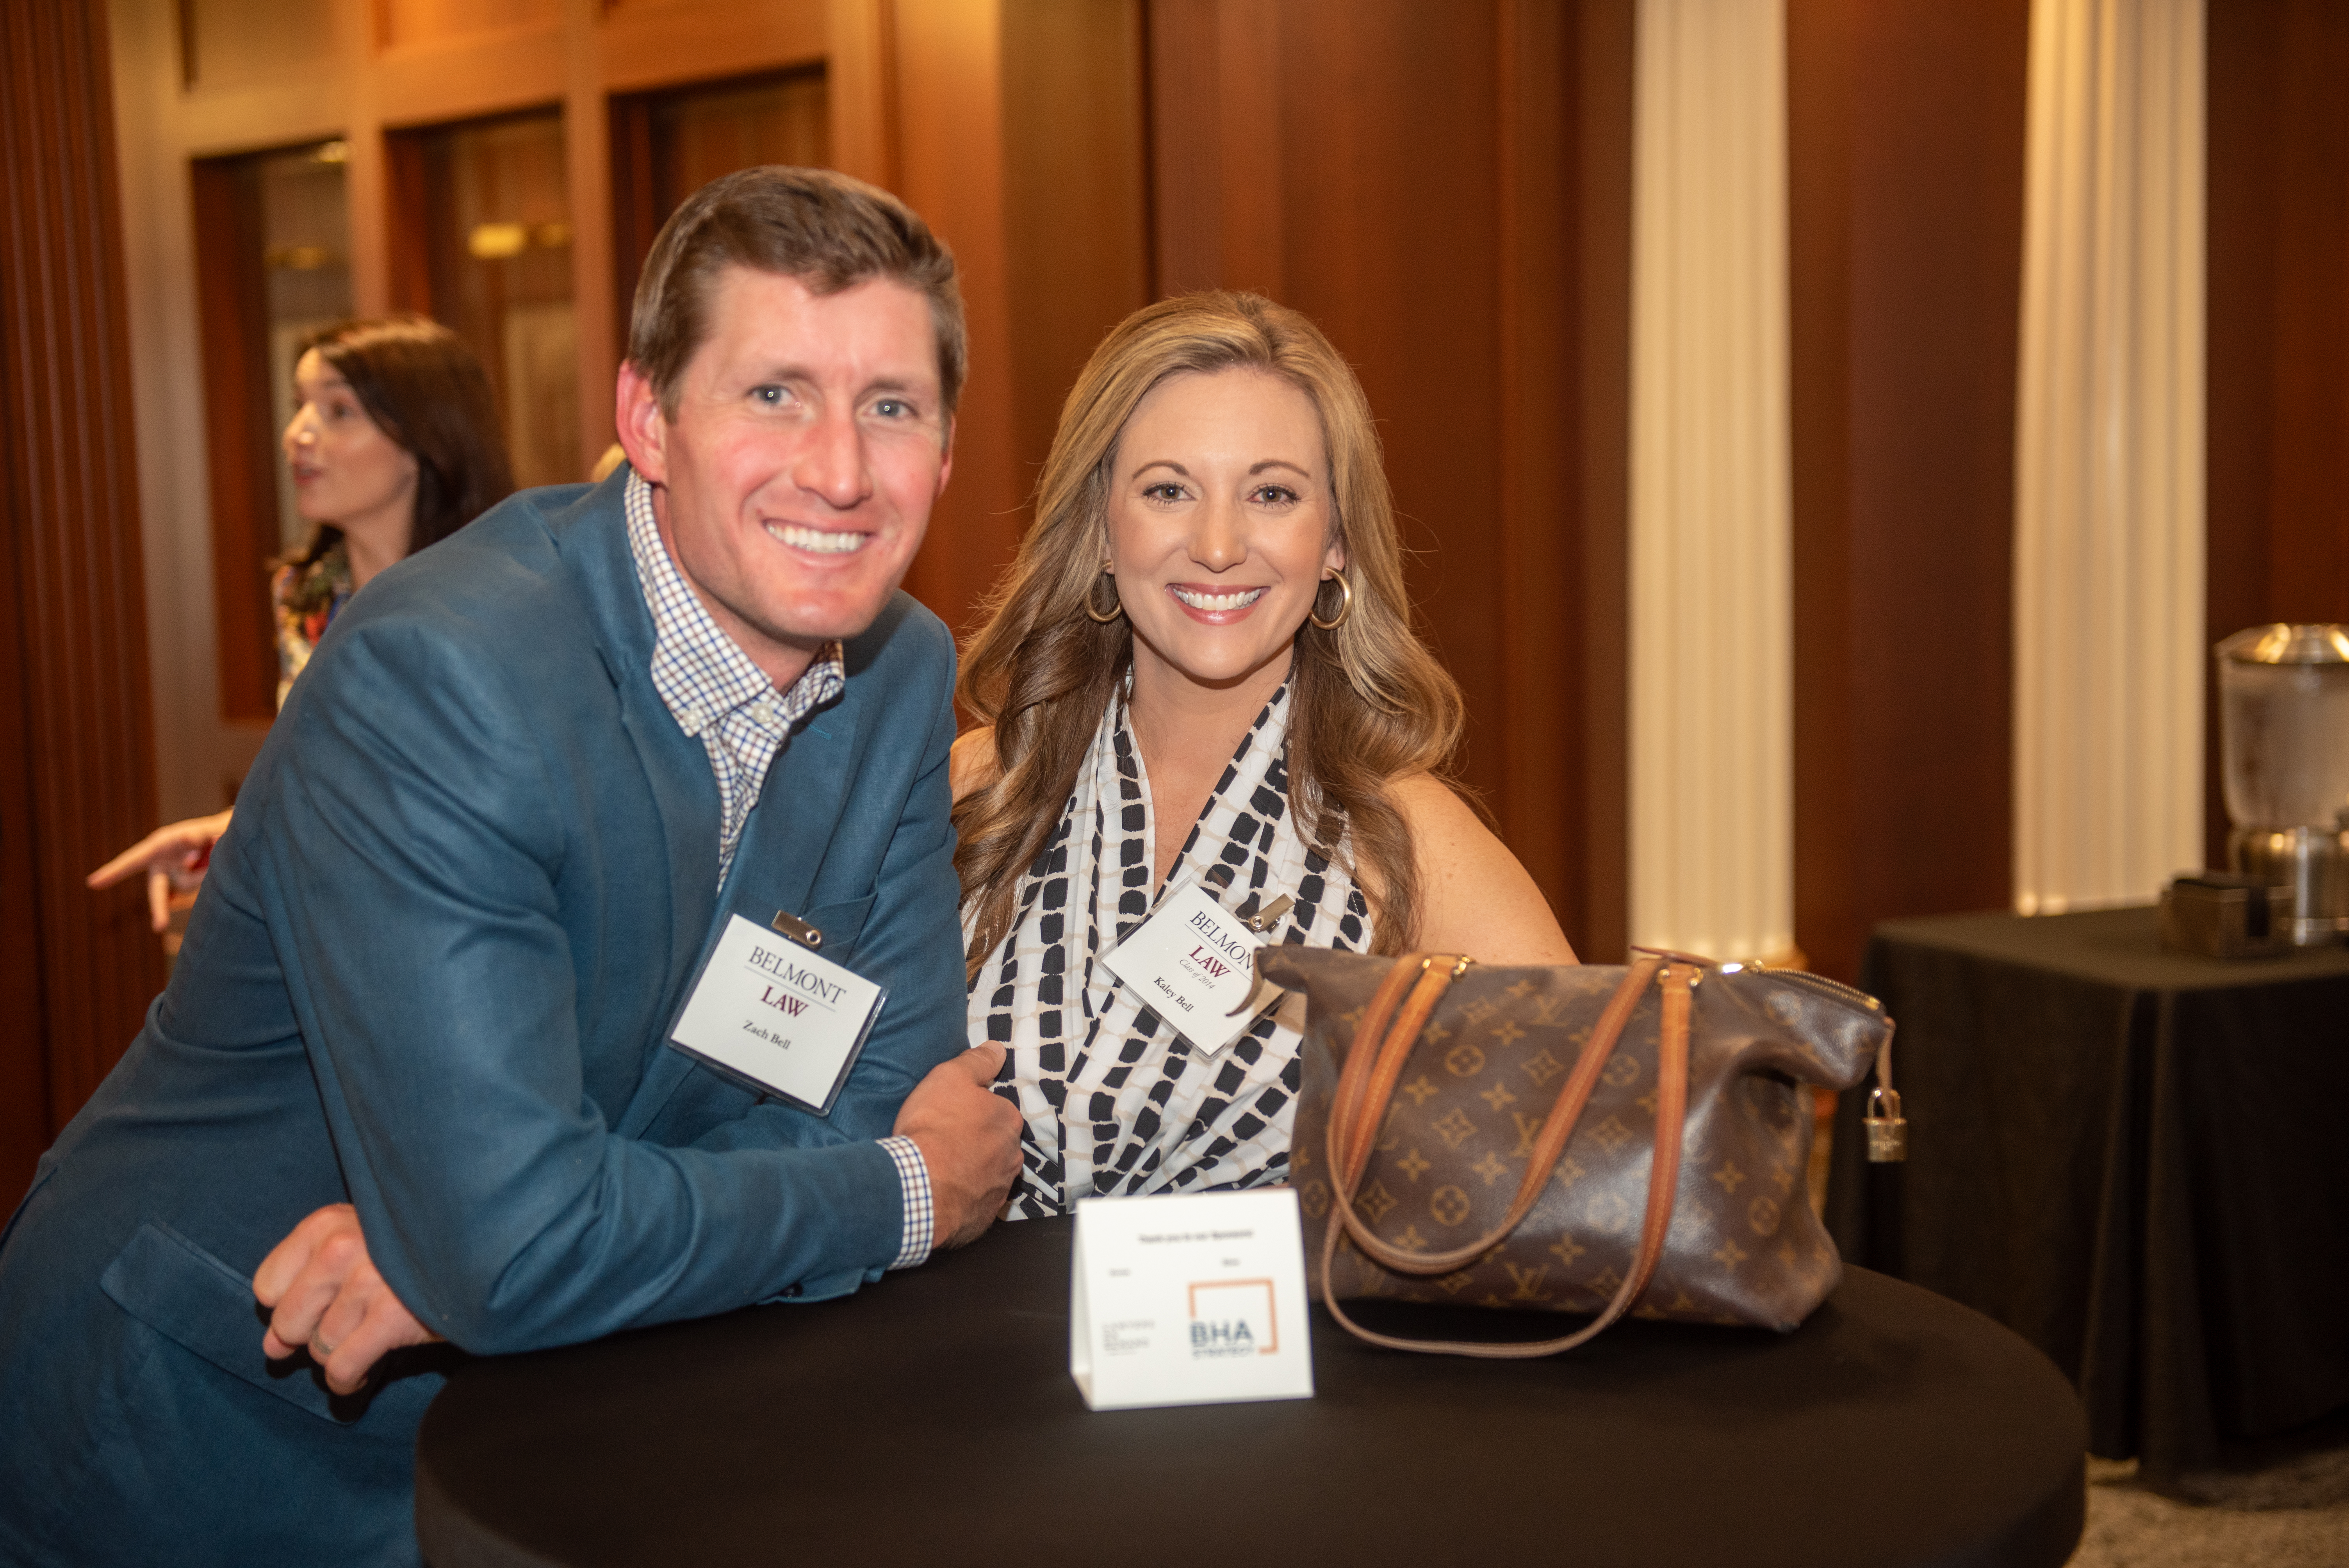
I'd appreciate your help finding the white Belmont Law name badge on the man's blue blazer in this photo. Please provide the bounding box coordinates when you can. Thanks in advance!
[670,916,888,1115]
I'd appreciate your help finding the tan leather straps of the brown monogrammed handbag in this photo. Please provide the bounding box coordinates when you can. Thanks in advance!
[1322,955,1703,1359]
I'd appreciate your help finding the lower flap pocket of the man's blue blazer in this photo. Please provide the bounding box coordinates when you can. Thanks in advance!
[99,1221,369,1425]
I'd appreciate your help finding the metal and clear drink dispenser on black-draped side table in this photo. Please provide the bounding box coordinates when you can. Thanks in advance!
[2213,622,2349,946]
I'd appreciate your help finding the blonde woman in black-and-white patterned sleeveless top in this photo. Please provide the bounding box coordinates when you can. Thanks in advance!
[954,293,1574,1218]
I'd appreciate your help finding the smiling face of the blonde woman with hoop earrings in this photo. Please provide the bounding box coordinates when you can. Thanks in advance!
[1109,369,1346,688]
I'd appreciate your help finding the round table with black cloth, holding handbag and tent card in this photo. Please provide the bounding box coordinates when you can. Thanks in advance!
[416,1221,2086,1568]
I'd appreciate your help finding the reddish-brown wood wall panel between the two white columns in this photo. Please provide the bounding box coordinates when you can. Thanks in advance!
[1788,0,2030,979]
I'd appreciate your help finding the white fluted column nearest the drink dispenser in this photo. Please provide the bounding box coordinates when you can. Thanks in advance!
[2016,0,2208,913]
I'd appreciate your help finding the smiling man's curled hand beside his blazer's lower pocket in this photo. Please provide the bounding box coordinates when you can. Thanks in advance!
[254,1211,442,1394]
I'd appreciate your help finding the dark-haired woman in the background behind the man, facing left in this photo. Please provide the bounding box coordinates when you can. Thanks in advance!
[89,317,515,932]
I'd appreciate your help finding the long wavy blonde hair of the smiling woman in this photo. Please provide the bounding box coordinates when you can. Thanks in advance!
[954,293,1463,974]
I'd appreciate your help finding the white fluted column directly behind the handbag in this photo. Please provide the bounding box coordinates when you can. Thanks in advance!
[1630,0,1795,958]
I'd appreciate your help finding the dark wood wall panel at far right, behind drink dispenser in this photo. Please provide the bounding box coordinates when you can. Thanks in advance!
[2203,0,2349,866]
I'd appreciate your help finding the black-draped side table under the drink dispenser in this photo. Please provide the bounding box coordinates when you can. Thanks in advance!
[1827,909,2349,1479]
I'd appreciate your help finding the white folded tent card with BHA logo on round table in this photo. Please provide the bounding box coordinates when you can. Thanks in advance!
[1069,1188,1313,1411]
